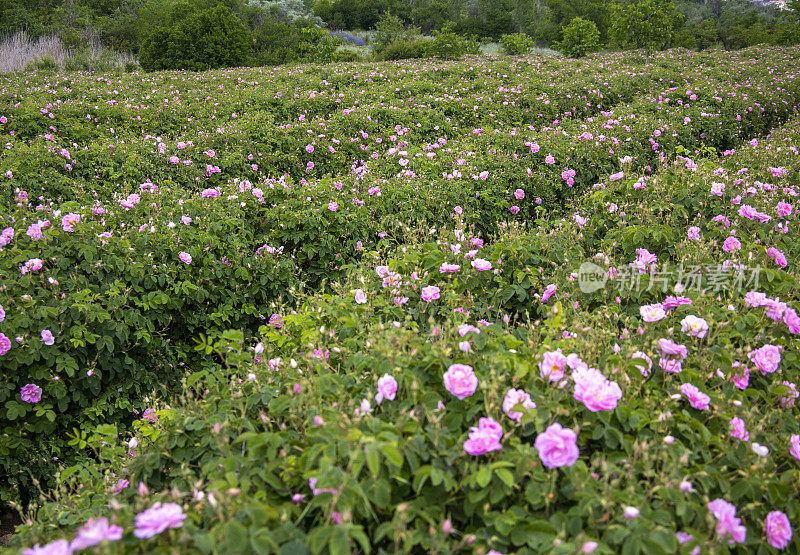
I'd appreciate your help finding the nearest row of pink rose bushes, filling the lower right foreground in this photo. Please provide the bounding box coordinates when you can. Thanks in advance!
[7,116,800,553]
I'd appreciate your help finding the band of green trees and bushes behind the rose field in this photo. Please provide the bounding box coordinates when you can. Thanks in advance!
[0,0,800,69]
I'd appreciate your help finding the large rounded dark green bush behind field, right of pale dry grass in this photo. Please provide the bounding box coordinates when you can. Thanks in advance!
[139,4,250,71]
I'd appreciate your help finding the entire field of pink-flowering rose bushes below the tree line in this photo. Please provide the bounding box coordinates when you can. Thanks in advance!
[0,47,800,555]
